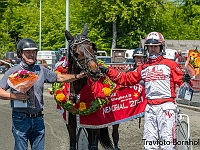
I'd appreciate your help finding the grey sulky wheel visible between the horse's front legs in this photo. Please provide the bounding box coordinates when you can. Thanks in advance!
[76,128,88,150]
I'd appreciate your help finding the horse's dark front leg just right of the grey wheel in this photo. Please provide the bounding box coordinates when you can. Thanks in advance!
[86,128,99,150]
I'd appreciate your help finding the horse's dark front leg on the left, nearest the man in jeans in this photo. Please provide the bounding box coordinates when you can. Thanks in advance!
[66,113,76,150]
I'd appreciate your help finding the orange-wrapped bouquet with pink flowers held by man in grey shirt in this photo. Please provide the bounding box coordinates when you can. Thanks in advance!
[7,70,38,93]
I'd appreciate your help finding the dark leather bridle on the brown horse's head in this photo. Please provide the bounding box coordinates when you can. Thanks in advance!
[69,35,99,81]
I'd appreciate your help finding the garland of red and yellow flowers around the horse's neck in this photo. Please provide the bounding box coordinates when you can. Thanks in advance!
[51,56,114,115]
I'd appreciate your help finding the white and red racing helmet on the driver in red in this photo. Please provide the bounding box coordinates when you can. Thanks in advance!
[144,32,165,53]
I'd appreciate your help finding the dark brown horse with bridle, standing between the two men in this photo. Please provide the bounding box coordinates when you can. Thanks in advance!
[65,24,113,150]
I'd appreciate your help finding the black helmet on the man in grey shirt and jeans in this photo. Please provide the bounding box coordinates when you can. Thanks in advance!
[17,38,38,58]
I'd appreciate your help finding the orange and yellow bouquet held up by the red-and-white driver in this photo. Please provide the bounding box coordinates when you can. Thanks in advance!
[185,49,200,76]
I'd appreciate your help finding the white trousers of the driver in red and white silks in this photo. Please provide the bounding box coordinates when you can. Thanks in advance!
[143,102,177,150]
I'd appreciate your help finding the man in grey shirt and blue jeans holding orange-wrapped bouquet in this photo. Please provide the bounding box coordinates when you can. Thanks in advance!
[0,38,85,150]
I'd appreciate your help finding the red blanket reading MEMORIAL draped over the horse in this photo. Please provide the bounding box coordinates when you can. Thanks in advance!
[56,78,147,128]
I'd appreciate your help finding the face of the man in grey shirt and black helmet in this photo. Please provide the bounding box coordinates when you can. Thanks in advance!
[22,50,36,65]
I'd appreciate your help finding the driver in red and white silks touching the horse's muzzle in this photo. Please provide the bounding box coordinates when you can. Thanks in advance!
[99,32,191,150]
